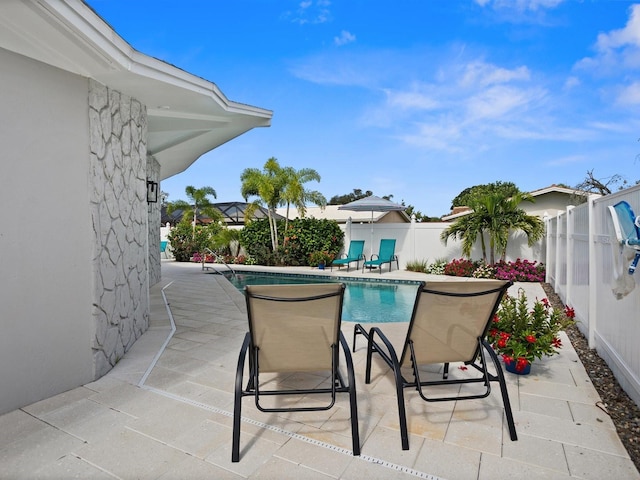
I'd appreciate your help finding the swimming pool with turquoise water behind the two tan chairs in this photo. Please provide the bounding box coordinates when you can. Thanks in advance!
[224,272,418,323]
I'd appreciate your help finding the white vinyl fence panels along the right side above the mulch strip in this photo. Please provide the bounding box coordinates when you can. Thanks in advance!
[545,186,640,405]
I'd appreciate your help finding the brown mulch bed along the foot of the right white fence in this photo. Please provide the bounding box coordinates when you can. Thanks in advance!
[541,283,640,470]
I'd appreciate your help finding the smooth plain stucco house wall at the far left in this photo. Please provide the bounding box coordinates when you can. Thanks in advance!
[0,49,94,413]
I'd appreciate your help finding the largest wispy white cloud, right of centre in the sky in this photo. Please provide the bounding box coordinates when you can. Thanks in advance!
[292,46,616,153]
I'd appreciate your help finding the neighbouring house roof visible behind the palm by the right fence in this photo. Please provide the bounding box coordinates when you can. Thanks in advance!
[442,185,593,222]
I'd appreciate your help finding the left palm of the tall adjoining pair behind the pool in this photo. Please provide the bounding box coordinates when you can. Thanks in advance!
[240,157,288,252]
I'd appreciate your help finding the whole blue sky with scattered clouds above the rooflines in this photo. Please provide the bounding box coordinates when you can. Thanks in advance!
[88,0,640,216]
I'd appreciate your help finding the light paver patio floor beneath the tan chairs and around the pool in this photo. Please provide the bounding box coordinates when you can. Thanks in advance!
[0,260,640,480]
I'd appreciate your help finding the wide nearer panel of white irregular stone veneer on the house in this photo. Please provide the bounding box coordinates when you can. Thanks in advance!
[89,80,149,378]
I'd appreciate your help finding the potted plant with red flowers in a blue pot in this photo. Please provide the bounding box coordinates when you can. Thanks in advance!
[488,289,575,374]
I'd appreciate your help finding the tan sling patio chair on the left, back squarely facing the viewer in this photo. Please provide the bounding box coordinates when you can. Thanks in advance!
[231,283,360,462]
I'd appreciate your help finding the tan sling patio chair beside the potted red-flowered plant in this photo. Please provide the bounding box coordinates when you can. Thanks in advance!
[353,279,518,450]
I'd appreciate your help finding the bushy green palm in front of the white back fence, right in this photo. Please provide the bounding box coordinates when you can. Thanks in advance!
[440,191,544,264]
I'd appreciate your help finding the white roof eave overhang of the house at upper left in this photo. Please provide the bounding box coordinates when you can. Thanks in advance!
[0,0,273,180]
